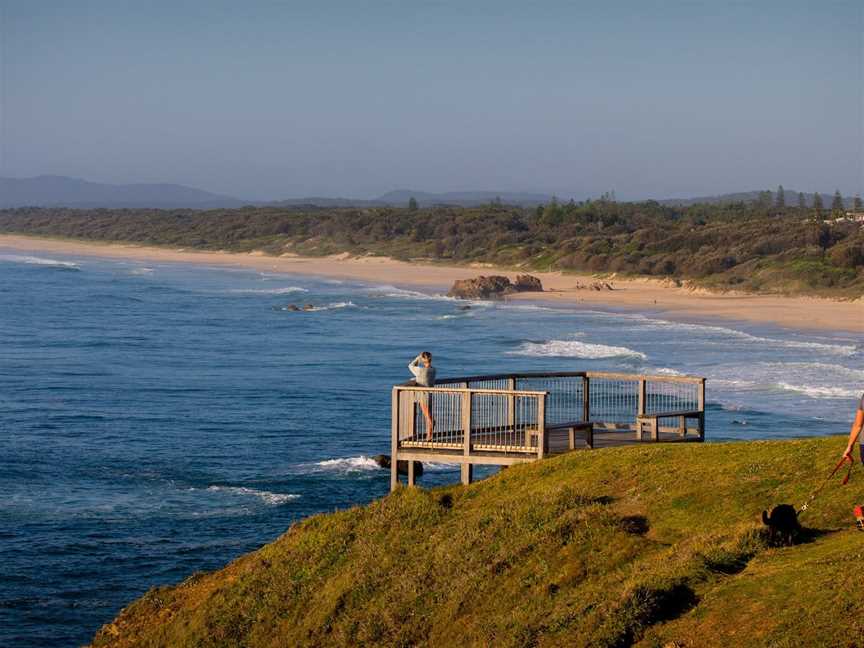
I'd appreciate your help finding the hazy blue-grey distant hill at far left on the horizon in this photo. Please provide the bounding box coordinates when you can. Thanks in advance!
[0,175,248,209]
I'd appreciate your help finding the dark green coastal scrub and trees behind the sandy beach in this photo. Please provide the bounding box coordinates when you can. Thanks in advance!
[0,197,864,298]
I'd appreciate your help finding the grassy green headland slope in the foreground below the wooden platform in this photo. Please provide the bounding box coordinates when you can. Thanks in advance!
[93,437,864,647]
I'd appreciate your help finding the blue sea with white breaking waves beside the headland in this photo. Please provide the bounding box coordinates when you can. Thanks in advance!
[0,249,864,647]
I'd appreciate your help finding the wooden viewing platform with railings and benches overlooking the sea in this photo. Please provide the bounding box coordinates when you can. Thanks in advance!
[390,371,705,489]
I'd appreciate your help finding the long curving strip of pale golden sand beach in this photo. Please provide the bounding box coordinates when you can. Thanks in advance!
[0,234,864,333]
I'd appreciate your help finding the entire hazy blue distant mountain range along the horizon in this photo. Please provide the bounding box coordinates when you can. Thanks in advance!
[0,175,852,209]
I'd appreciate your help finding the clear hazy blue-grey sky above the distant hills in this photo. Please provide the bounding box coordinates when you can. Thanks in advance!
[0,0,864,200]
